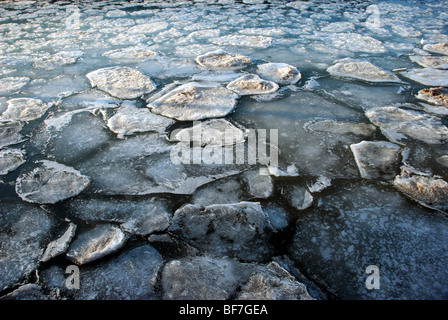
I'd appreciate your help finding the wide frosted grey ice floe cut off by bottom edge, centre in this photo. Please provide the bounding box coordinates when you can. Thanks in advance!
[162,256,313,300]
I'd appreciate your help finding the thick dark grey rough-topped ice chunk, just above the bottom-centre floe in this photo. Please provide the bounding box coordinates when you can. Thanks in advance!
[169,202,273,261]
